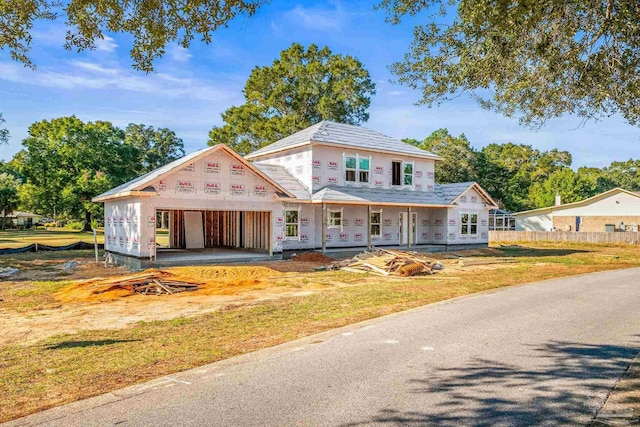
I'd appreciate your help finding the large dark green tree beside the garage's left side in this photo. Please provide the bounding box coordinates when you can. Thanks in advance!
[11,116,184,229]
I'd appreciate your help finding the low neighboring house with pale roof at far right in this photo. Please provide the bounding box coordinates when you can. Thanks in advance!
[513,188,640,232]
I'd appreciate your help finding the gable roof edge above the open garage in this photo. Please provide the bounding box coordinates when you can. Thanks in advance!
[91,144,295,202]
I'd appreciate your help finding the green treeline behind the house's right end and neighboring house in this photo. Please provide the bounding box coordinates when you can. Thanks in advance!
[404,129,640,212]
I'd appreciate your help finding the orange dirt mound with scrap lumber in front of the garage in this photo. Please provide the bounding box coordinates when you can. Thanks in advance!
[87,271,199,295]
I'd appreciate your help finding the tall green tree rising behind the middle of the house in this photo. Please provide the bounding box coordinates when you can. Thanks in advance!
[209,43,375,154]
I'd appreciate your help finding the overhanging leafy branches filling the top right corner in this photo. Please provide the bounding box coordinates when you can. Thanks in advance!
[380,0,640,126]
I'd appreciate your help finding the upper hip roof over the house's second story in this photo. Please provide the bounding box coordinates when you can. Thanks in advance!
[245,120,441,160]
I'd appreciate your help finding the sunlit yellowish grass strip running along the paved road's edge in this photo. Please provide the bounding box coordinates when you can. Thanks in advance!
[0,243,640,422]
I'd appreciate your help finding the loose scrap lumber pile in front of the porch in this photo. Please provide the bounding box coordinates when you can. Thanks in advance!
[328,248,442,277]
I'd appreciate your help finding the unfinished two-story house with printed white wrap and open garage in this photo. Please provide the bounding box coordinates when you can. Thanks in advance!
[94,121,497,264]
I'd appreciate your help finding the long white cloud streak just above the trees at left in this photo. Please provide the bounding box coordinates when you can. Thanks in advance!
[0,61,239,102]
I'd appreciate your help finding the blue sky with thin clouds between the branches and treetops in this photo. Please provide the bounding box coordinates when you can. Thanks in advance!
[0,0,640,167]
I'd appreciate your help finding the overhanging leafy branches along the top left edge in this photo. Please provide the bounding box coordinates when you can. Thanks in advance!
[0,0,268,72]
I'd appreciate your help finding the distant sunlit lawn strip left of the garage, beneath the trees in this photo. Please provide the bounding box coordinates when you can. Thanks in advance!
[0,229,104,249]
